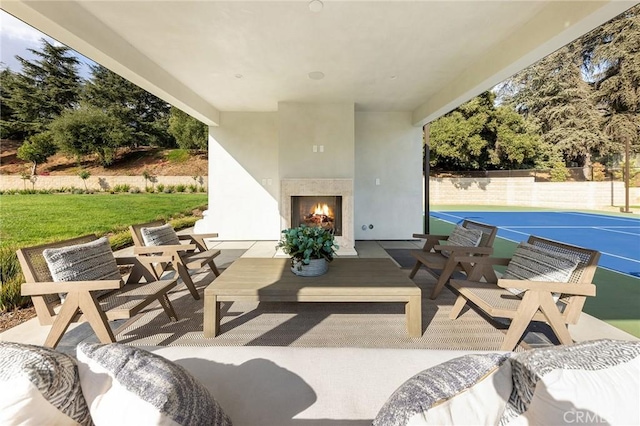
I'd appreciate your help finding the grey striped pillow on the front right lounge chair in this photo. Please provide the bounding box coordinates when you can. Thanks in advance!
[502,241,580,301]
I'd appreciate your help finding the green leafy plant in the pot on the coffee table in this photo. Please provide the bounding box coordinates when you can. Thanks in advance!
[277,225,338,265]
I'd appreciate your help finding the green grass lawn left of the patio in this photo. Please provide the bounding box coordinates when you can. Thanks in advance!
[0,193,207,247]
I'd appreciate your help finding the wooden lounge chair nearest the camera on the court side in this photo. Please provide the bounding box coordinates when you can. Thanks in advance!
[449,236,600,351]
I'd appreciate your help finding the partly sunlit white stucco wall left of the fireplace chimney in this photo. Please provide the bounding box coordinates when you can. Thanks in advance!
[195,112,280,240]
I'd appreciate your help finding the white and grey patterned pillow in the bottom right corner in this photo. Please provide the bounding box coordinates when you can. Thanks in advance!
[500,339,640,425]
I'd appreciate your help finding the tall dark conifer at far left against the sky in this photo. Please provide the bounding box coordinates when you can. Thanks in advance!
[5,39,81,136]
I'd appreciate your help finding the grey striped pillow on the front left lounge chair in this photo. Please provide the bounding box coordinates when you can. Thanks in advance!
[42,237,122,299]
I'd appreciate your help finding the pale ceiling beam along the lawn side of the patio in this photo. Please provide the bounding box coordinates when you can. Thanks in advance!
[2,0,220,125]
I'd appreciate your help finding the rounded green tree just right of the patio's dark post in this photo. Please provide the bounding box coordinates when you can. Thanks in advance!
[430,92,541,170]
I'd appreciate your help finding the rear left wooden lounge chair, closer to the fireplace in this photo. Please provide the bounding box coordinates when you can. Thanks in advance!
[129,220,220,300]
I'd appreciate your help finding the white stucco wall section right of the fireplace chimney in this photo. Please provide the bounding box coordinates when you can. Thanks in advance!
[354,112,423,240]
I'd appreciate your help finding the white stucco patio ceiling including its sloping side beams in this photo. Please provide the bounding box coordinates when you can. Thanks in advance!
[1,0,635,125]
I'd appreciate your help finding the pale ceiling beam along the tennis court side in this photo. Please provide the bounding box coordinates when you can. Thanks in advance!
[413,0,637,126]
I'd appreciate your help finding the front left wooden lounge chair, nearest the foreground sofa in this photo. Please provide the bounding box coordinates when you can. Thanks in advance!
[17,235,177,348]
